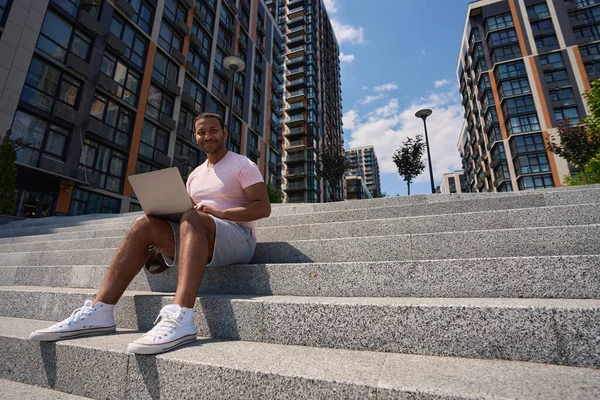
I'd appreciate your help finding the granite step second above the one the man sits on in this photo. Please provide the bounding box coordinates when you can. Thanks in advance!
[0,203,600,250]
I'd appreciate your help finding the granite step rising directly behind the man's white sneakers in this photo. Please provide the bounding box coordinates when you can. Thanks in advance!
[0,287,600,368]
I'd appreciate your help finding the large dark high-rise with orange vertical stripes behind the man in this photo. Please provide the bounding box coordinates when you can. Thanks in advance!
[0,0,284,216]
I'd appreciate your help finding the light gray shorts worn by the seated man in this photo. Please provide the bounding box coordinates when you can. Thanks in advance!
[163,214,256,267]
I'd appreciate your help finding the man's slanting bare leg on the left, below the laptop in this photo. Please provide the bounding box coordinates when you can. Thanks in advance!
[94,216,175,304]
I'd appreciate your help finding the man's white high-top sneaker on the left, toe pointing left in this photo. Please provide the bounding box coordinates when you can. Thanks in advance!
[29,300,117,342]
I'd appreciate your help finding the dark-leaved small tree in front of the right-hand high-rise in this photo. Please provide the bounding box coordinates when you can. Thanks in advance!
[547,117,600,184]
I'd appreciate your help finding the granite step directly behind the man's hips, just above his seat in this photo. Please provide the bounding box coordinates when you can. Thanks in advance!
[0,224,600,266]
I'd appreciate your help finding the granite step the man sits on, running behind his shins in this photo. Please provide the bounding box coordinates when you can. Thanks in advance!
[0,255,600,299]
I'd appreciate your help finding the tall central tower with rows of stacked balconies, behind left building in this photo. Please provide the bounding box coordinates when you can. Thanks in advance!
[273,0,344,203]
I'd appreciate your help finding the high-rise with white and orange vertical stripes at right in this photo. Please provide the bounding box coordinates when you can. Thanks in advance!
[457,0,600,192]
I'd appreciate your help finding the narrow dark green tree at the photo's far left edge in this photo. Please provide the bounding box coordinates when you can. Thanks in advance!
[0,129,22,215]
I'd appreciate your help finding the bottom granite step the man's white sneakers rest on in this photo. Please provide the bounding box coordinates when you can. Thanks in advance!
[0,317,600,400]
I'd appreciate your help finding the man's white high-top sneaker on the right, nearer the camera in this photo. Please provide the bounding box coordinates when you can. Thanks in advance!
[127,304,196,354]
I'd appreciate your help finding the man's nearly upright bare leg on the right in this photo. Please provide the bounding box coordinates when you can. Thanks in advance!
[173,210,217,308]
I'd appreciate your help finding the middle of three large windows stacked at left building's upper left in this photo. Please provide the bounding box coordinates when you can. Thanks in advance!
[21,58,81,112]
